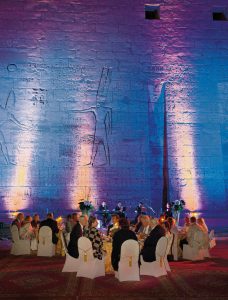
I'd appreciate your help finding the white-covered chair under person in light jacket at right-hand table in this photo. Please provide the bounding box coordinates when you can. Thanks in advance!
[183,231,205,261]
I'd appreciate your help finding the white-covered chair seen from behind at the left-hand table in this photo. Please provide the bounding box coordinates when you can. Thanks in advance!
[37,226,55,257]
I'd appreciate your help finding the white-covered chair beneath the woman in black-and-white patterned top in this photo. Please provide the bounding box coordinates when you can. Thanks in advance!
[77,237,105,279]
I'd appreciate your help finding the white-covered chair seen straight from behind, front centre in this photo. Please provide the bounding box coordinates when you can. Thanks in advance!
[115,240,140,281]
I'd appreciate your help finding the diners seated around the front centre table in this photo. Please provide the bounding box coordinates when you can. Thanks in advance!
[66,214,170,271]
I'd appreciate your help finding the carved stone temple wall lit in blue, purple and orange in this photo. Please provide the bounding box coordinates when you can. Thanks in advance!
[0,0,228,213]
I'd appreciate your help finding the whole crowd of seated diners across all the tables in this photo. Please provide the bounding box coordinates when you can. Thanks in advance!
[12,213,209,271]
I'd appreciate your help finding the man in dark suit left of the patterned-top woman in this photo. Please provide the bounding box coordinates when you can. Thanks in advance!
[67,215,88,258]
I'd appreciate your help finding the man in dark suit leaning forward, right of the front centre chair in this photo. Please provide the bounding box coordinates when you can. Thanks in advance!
[141,225,165,262]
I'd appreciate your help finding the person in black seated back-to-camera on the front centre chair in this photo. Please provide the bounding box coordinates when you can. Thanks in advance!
[111,218,137,271]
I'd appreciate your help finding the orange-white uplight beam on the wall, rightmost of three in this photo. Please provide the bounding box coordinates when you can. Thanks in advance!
[169,83,200,211]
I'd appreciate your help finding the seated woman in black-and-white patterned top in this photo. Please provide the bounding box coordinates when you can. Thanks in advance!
[85,216,103,260]
